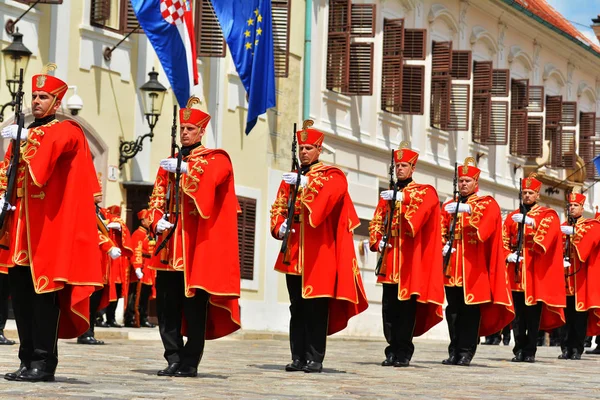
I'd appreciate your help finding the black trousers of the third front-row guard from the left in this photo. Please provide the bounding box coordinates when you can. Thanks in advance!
[285,274,329,363]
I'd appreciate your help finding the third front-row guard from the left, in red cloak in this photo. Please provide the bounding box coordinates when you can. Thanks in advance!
[271,120,368,372]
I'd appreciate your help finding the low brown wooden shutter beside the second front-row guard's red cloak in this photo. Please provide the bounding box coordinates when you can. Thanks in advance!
[237,196,256,280]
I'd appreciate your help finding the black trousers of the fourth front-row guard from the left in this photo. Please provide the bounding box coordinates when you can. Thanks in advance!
[381,283,417,360]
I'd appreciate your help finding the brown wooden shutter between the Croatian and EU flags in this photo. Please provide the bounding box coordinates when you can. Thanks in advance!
[196,0,226,57]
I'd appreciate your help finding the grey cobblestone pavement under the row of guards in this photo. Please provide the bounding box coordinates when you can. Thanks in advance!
[0,330,600,400]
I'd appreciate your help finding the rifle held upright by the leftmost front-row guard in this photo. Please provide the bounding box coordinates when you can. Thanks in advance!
[0,68,25,250]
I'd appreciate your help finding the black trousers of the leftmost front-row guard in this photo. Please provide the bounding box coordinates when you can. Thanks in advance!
[9,266,60,373]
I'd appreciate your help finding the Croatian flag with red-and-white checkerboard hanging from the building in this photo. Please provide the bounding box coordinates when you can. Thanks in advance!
[131,0,198,107]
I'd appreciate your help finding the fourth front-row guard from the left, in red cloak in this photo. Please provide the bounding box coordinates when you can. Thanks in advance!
[369,144,444,367]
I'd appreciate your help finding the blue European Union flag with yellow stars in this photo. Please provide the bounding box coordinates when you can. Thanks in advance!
[211,0,275,134]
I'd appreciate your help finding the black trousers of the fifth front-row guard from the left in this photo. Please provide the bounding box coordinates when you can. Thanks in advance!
[445,286,481,359]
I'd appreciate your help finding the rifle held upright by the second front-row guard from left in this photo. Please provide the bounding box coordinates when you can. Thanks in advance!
[154,105,183,258]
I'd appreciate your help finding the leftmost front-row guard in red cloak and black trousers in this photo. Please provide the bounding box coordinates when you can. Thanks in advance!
[0,64,102,382]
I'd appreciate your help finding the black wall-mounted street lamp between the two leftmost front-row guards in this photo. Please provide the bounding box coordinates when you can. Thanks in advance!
[119,68,167,168]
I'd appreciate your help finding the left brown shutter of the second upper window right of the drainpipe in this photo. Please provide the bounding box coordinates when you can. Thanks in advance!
[381,18,404,114]
